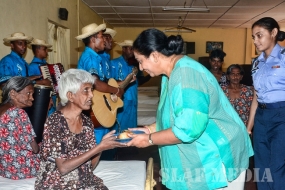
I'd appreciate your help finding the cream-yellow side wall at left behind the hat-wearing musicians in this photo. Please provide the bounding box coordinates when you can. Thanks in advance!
[0,0,103,68]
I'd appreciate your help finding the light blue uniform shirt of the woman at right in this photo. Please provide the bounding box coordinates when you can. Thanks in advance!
[252,44,285,103]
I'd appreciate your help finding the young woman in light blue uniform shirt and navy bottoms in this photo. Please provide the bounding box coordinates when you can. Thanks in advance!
[247,17,285,190]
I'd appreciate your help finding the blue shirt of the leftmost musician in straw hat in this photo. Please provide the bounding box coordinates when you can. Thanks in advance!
[0,51,28,83]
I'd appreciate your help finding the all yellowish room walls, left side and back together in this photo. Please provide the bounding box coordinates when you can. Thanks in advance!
[0,0,285,81]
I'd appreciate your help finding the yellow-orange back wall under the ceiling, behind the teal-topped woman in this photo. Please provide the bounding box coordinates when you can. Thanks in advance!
[113,27,252,69]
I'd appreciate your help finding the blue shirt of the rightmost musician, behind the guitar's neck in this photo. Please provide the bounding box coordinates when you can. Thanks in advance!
[111,56,138,103]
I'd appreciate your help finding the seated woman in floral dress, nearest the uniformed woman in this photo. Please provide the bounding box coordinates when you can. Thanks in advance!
[221,64,253,125]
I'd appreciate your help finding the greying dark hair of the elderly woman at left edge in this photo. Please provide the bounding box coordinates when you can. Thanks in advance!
[2,76,33,104]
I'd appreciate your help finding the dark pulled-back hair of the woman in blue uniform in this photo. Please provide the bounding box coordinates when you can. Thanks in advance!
[251,17,285,42]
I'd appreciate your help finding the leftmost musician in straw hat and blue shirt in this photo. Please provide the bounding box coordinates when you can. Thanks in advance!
[0,32,50,85]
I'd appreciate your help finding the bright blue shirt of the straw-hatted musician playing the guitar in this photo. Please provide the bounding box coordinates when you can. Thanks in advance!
[77,47,107,81]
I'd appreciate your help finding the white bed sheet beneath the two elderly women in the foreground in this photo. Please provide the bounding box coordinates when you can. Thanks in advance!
[0,161,146,190]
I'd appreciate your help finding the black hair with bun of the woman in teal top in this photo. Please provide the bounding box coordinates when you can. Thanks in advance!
[133,28,184,57]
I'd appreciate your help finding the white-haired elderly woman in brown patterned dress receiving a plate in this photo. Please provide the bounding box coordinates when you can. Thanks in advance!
[35,69,126,189]
